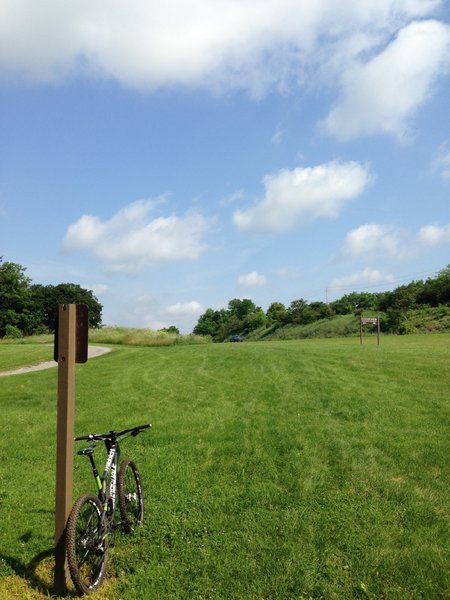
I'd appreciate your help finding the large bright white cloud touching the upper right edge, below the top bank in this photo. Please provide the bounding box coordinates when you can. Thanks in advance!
[322,20,450,139]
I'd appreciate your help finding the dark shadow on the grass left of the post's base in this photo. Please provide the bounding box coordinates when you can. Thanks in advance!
[0,548,76,598]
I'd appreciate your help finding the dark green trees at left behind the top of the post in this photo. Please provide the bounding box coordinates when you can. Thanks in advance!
[0,257,103,338]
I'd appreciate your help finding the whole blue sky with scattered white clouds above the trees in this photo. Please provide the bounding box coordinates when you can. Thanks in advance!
[0,0,450,332]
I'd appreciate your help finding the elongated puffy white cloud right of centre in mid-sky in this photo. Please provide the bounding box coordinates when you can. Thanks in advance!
[233,161,371,232]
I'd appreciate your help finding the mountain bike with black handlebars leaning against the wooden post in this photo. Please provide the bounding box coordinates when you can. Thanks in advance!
[66,424,151,594]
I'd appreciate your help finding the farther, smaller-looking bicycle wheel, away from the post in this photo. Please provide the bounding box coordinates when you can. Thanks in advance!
[117,458,144,533]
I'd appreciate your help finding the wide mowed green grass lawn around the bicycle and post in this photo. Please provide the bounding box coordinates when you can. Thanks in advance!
[0,335,450,600]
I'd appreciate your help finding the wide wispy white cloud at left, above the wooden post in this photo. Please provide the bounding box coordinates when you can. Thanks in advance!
[64,200,212,271]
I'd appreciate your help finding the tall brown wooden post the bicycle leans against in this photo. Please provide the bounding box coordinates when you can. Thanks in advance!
[54,304,76,594]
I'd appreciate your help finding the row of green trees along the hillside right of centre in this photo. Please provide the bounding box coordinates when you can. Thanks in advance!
[193,265,450,342]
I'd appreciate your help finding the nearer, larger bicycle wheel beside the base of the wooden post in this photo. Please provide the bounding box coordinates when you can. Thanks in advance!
[66,494,108,594]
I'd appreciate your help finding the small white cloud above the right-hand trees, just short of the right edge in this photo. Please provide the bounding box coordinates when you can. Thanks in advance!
[340,223,403,258]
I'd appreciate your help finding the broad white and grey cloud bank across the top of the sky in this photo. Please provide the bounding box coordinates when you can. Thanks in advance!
[0,0,440,95]
